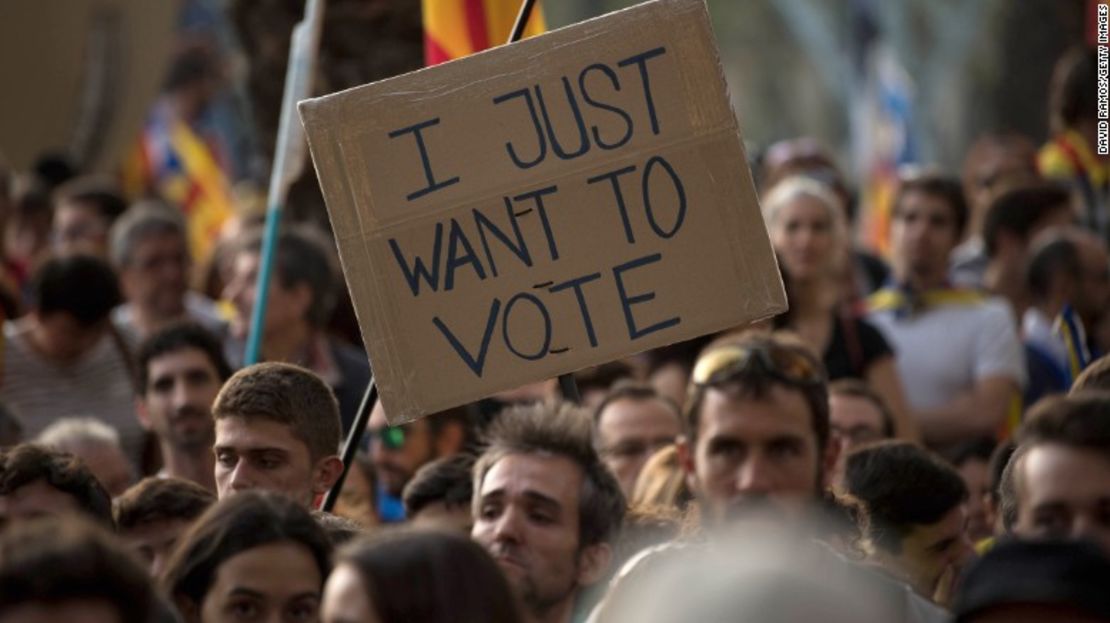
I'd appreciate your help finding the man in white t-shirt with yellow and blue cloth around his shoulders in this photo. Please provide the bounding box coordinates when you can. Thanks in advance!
[869,173,1026,445]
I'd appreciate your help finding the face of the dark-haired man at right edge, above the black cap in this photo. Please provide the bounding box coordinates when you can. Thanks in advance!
[1013,443,1110,552]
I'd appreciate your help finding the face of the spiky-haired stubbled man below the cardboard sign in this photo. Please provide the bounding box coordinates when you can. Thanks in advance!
[472,454,584,613]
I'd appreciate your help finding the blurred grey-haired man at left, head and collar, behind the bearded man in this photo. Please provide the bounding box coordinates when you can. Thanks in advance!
[111,201,226,342]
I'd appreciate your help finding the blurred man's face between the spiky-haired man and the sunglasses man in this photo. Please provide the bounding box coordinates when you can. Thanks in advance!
[597,399,682,499]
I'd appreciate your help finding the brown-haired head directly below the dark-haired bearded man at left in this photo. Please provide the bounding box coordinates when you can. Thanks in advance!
[113,478,215,577]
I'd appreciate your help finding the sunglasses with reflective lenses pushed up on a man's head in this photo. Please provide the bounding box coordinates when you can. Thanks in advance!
[690,344,825,386]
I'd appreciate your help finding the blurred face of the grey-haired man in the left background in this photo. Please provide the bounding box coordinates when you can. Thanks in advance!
[120,233,189,319]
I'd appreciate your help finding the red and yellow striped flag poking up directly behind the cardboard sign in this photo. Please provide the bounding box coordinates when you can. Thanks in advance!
[422,0,545,66]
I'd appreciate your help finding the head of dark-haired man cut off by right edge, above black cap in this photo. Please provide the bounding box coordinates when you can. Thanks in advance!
[1003,392,1110,552]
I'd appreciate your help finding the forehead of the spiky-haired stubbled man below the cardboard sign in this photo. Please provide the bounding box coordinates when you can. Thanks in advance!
[481,453,584,506]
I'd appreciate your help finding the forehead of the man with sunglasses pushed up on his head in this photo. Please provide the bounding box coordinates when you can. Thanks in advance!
[698,384,816,441]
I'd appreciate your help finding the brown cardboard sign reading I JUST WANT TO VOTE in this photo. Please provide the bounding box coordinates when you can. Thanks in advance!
[300,0,786,423]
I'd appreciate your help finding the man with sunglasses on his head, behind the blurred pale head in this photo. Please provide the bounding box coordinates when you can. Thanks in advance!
[595,333,947,623]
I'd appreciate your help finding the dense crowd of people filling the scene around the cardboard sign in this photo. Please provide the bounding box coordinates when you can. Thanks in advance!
[0,9,1110,623]
